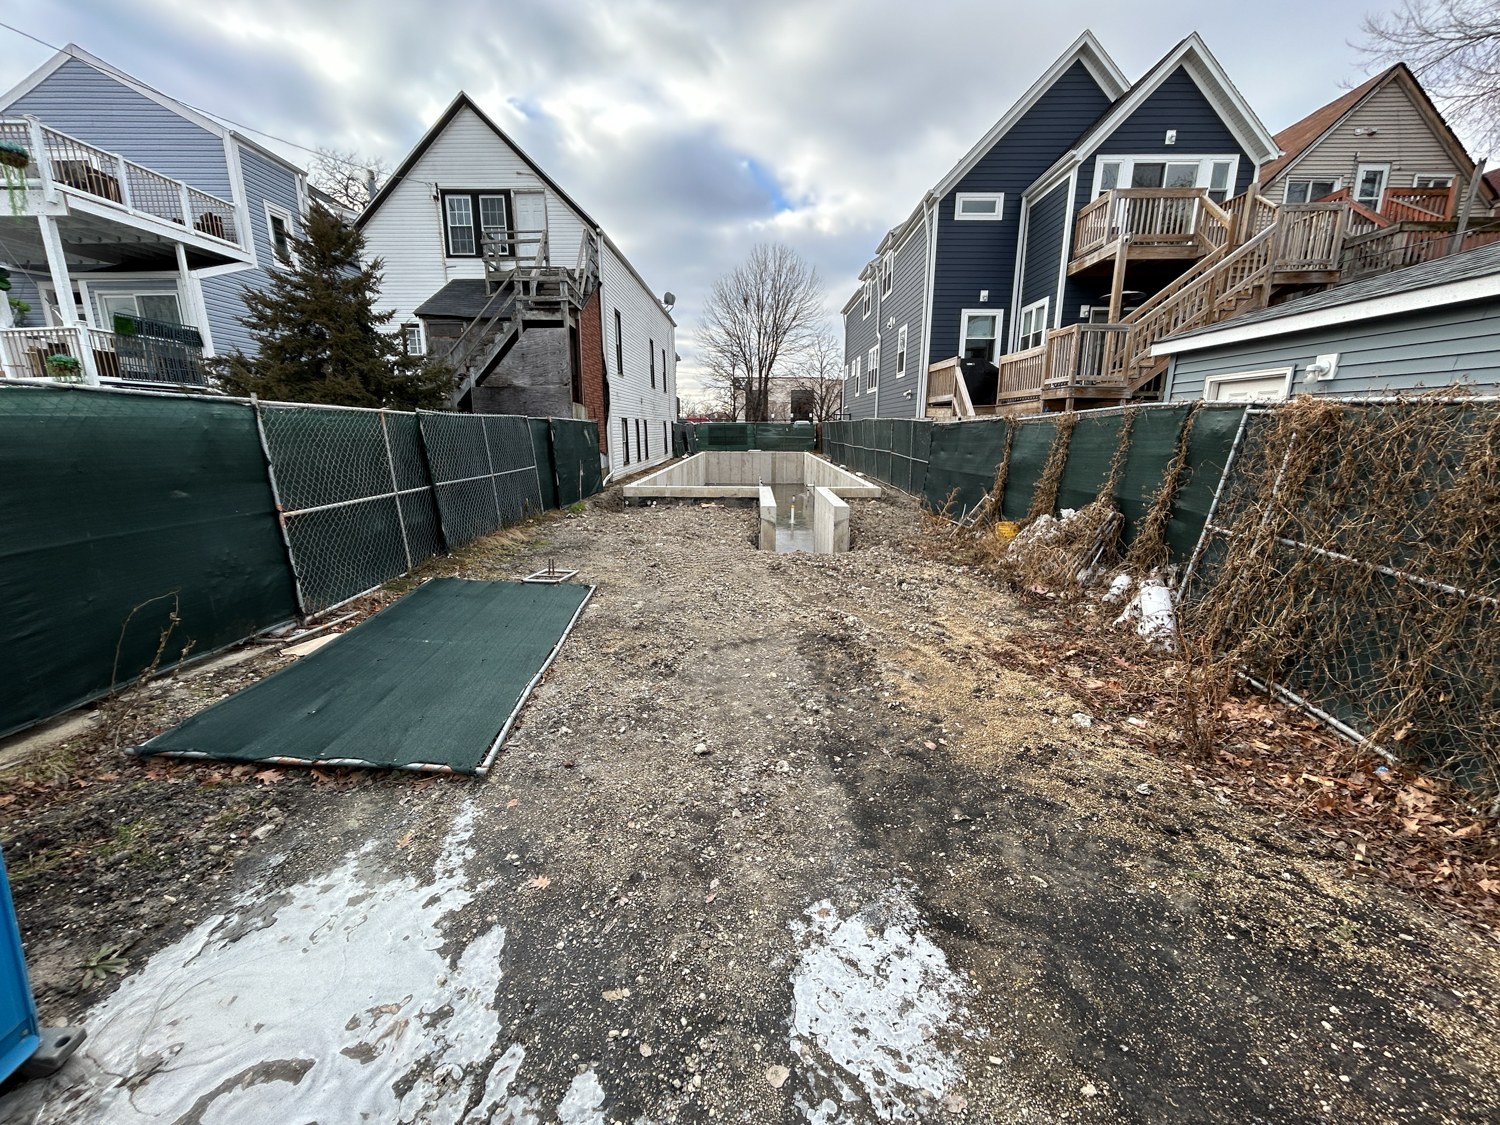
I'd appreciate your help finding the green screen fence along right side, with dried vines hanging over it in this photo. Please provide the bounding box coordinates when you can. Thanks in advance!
[824,402,1245,563]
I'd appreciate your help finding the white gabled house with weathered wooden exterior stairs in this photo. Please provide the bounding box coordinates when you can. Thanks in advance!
[356,93,678,473]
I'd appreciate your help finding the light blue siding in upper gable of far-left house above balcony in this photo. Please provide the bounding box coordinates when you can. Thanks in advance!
[6,59,230,200]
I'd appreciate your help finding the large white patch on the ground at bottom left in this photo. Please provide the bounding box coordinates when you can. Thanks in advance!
[0,806,603,1125]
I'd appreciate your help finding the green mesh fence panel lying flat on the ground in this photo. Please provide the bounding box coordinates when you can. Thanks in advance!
[140,578,591,774]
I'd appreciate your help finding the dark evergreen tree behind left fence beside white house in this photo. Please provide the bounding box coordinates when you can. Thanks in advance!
[216,204,455,410]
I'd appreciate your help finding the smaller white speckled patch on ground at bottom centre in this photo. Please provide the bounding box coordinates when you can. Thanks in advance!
[791,891,966,1125]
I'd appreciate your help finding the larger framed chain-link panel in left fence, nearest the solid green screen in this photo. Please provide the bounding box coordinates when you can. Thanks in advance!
[258,402,443,614]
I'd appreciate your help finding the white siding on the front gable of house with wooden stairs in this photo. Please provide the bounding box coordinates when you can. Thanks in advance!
[365,107,584,324]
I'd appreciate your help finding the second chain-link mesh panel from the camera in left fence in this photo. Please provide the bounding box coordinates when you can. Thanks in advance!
[417,410,542,549]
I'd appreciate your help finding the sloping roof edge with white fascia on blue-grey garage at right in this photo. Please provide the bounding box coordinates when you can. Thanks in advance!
[1152,243,1500,356]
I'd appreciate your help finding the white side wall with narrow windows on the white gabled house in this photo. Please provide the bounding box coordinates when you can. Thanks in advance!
[600,243,677,473]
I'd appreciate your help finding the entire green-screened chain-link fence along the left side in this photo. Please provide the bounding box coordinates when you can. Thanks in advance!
[0,386,602,734]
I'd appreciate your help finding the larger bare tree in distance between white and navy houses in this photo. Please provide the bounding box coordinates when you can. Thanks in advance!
[698,243,824,422]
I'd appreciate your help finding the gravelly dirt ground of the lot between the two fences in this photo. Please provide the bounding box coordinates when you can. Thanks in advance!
[0,492,1500,1125]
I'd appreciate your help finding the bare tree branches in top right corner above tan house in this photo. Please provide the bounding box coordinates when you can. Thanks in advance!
[1359,0,1500,150]
